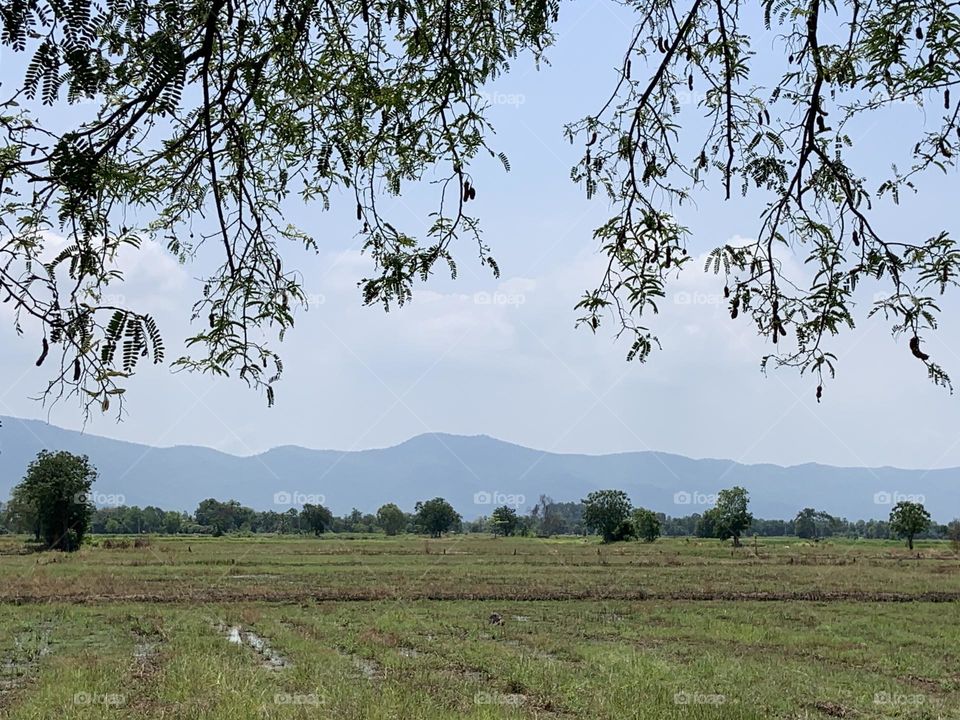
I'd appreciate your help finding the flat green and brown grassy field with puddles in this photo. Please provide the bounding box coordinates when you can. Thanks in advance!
[0,536,960,720]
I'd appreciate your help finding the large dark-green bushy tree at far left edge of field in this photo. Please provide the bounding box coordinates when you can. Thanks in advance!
[14,450,97,552]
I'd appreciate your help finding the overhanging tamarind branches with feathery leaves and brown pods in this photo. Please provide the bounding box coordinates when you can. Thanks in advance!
[0,0,960,410]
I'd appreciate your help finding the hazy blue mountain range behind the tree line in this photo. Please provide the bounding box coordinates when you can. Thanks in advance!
[0,417,960,522]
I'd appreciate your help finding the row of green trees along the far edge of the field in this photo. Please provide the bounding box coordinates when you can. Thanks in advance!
[0,451,960,550]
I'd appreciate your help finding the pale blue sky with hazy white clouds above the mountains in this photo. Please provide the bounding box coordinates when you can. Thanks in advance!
[0,2,960,468]
